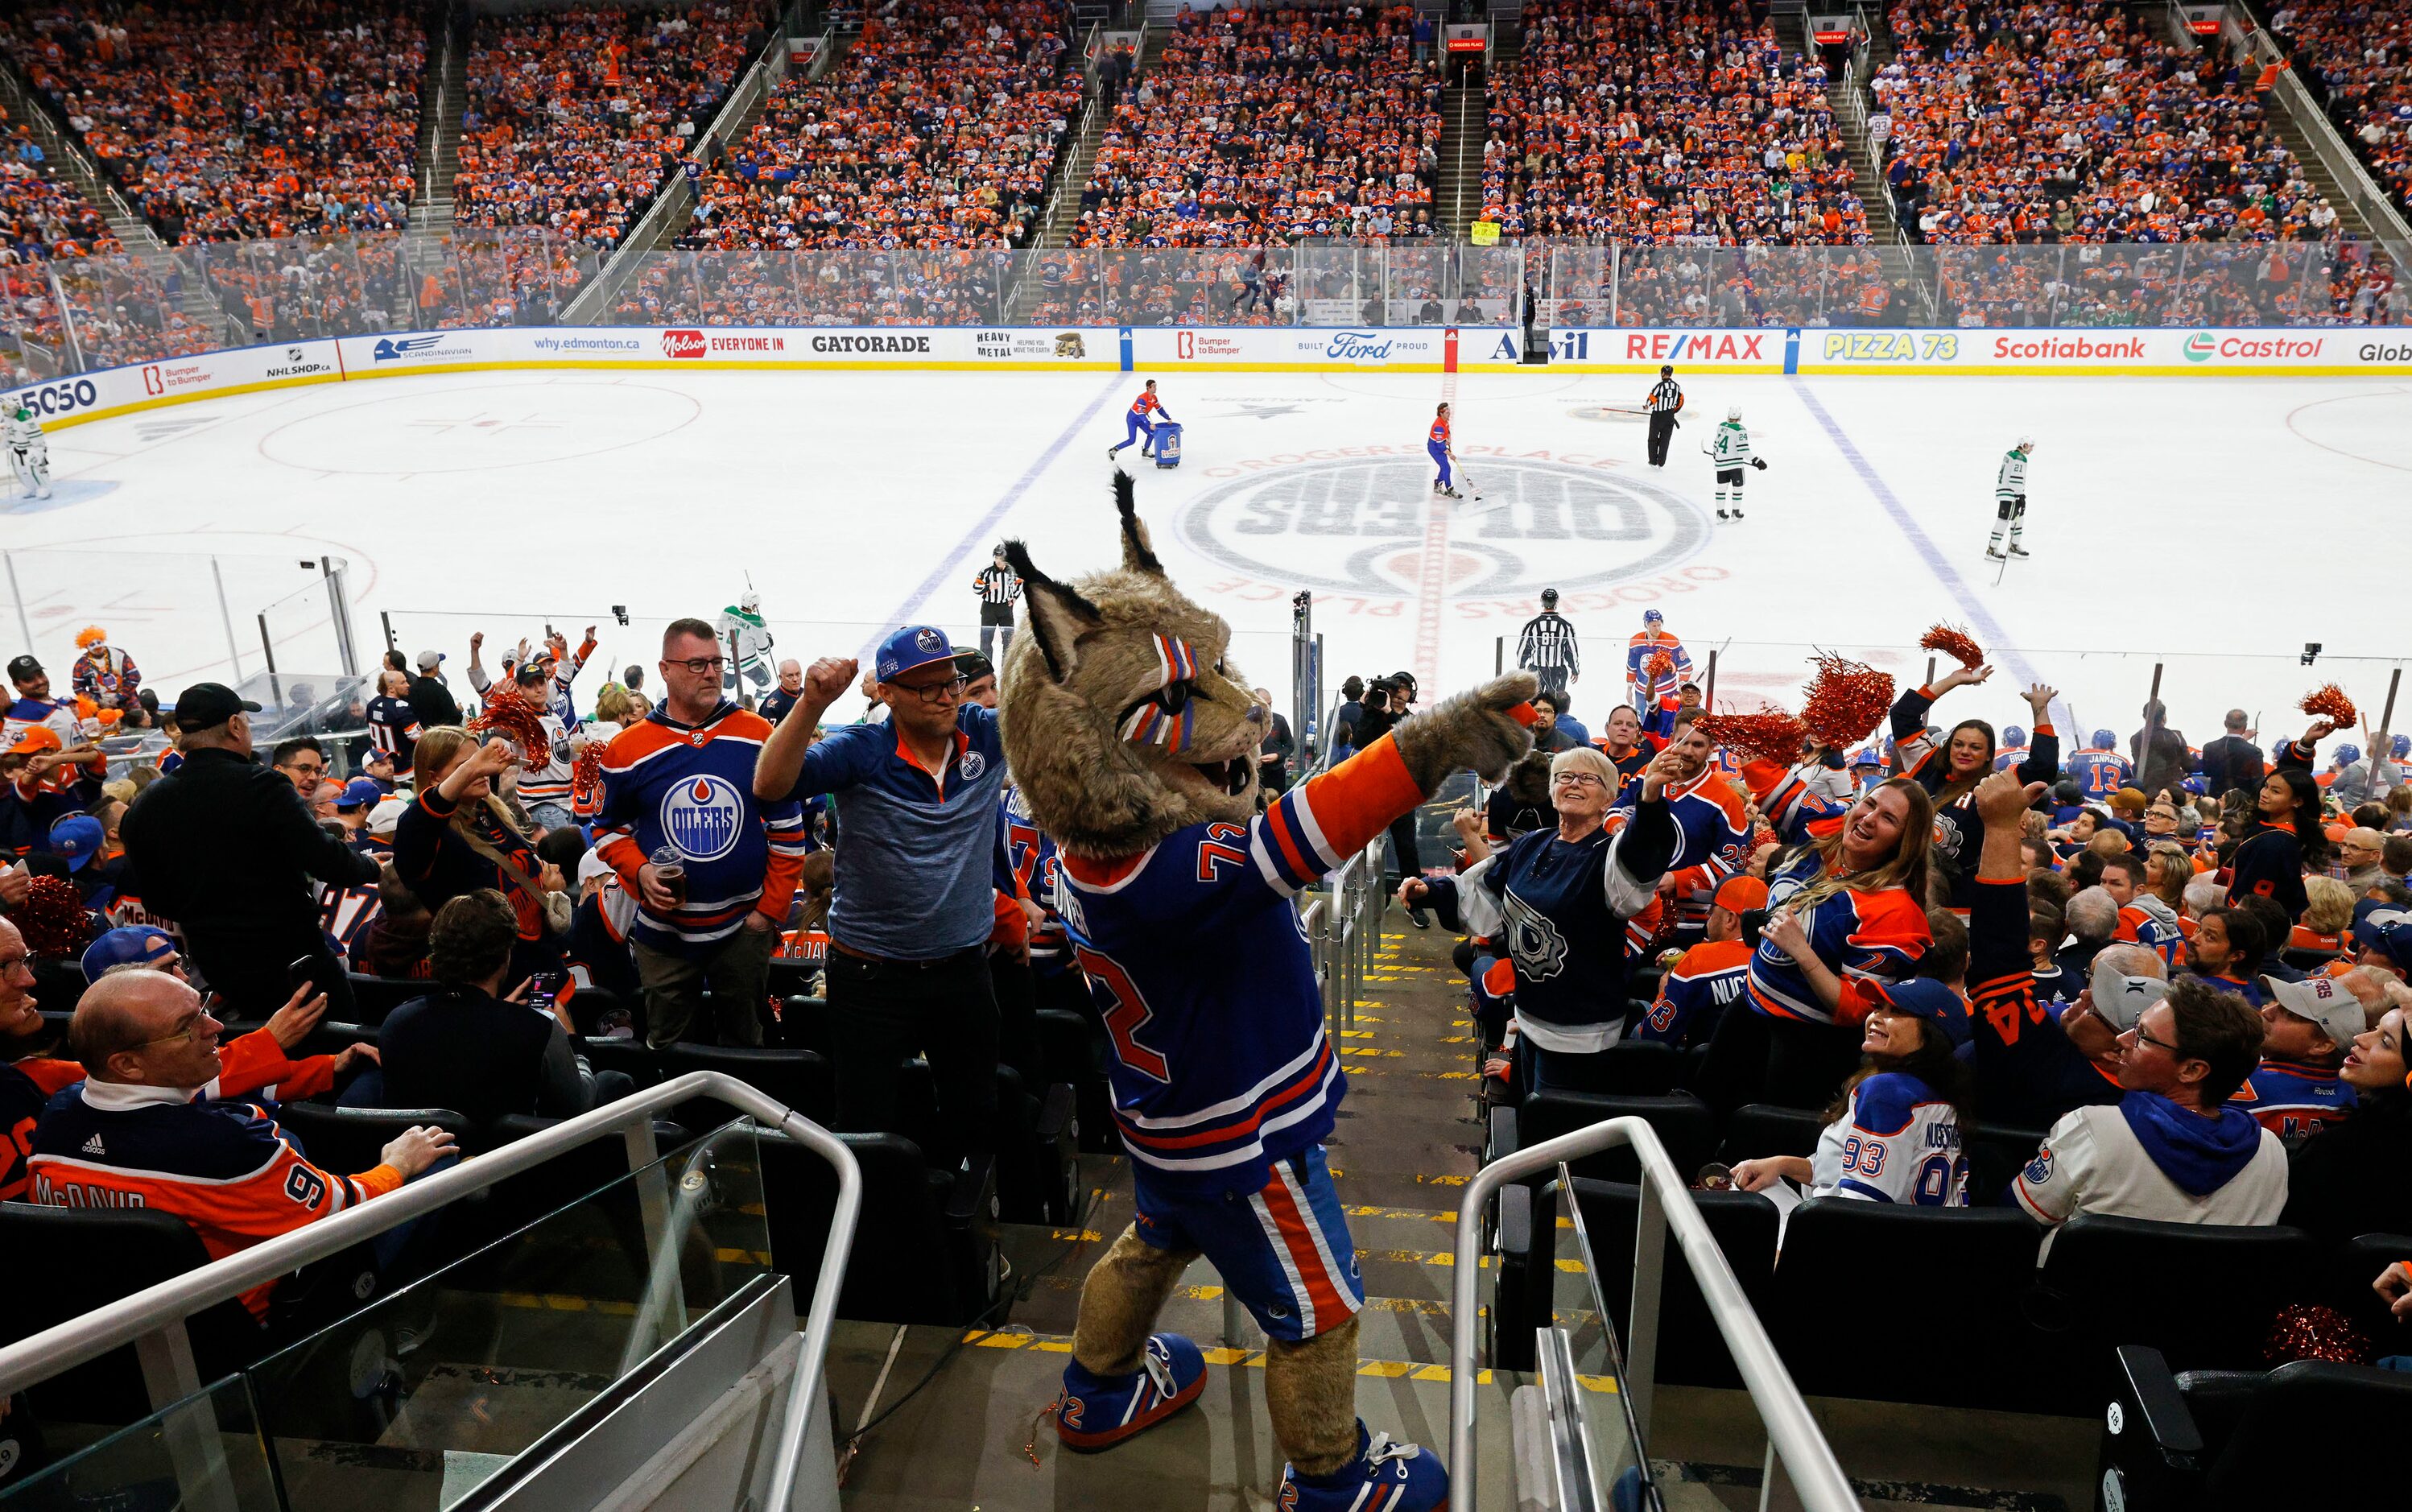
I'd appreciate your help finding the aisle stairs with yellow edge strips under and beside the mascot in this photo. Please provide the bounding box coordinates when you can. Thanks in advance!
[830,911,1543,1512]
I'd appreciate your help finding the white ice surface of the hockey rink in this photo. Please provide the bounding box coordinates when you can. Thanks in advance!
[0,371,2412,743]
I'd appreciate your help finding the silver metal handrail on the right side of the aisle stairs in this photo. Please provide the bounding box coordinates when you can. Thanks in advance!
[1450,1119,1860,1512]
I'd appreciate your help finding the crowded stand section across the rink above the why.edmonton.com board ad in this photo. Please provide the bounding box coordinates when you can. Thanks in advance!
[453,0,767,249]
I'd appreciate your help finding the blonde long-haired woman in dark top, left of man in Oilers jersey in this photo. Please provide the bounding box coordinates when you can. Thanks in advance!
[393,724,572,974]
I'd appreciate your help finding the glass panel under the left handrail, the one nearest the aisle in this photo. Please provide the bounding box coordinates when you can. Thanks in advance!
[251,1124,770,1512]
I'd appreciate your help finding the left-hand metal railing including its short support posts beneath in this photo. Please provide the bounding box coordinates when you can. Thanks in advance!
[0,1071,864,1507]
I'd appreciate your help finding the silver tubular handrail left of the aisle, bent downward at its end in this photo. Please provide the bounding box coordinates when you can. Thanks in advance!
[0,1071,864,1512]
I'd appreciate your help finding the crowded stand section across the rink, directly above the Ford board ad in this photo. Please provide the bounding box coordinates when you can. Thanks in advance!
[1071,5,1440,249]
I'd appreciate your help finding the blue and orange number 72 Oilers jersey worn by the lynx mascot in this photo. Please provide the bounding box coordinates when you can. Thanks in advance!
[1056,736,1423,1192]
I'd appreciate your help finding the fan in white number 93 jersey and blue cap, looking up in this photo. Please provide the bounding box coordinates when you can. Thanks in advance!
[1734,977,1968,1208]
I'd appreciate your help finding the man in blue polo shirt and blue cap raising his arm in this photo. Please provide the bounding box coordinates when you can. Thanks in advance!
[755,625,1006,1158]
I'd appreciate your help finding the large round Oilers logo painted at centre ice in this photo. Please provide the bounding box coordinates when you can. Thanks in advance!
[1177,456,1710,598]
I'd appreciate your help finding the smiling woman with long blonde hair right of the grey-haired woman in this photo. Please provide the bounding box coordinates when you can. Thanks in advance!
[1693,762,1935,1109]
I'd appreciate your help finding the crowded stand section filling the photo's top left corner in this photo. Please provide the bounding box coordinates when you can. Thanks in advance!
[0,0,427,244]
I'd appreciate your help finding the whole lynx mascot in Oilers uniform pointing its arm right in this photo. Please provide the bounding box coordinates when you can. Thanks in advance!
[998,473,1534,1512]
